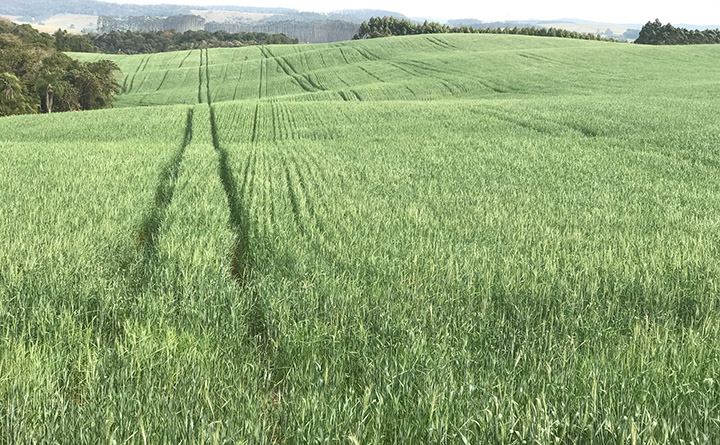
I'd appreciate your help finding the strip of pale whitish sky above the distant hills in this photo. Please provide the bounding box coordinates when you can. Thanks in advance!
[97,0,720,25]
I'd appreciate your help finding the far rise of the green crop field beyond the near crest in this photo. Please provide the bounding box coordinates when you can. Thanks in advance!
[73,35,720,106]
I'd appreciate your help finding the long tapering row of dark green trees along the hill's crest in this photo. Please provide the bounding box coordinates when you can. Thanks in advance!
[353,17,616,42]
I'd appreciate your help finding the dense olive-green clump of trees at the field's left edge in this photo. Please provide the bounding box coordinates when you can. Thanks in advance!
[0,20,120,116]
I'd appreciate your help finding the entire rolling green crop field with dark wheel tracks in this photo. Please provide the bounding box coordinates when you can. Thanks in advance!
[0,35,720,444]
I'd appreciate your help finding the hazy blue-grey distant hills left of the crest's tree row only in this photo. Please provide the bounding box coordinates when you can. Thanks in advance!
[0,0,405,43]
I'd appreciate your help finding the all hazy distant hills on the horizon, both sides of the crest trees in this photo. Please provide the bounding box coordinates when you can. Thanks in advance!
[0,0,718,43]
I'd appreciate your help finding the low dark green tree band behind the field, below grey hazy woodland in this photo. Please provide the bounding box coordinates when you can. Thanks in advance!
[87,31,297,54]
